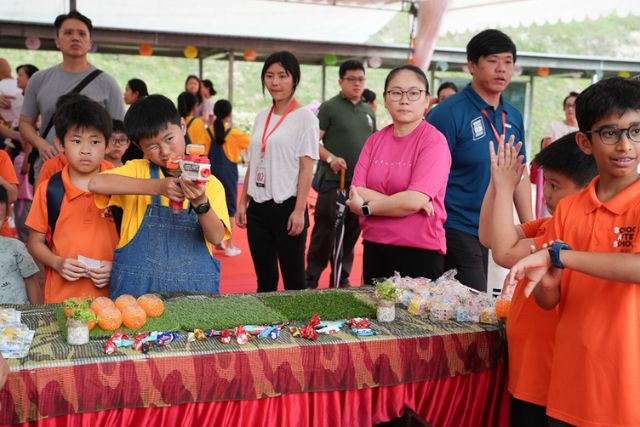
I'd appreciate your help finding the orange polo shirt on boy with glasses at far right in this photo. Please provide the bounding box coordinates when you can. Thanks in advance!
[536,177,640,426]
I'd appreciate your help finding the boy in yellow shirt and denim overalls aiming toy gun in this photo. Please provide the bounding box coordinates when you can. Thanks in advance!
[89,95,230,298]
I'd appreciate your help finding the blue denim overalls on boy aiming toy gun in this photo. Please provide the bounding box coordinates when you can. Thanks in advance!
[109,160,220,298]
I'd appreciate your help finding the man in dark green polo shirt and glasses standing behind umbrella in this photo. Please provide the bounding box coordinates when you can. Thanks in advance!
[306,60,376,289]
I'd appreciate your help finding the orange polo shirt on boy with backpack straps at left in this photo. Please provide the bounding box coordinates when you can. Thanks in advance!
[26,164,118,303]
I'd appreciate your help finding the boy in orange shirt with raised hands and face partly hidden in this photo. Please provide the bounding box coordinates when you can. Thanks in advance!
[479,132,598,427]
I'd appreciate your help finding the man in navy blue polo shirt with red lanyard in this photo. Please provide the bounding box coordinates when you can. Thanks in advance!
[427,30,533,291]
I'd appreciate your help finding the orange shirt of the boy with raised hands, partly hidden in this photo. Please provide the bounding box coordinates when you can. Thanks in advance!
[507,217,558,406]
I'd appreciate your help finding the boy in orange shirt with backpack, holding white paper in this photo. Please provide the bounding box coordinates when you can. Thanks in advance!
[26,94,118,303]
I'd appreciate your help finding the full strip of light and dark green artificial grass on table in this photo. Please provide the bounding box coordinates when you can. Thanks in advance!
[55,291,375,339]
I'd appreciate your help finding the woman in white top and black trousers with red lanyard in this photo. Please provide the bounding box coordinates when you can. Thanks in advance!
[236,51,320,292]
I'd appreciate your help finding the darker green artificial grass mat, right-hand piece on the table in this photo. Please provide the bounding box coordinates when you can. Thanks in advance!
[259,290,376,321]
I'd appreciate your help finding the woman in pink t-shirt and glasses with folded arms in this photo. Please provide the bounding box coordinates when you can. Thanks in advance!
[347,65,451,284]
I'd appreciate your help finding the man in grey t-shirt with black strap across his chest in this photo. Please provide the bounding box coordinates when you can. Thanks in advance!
[20,11,124,177]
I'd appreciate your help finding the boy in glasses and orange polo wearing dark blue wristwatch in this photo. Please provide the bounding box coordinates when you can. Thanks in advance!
[508,77,640,426]
